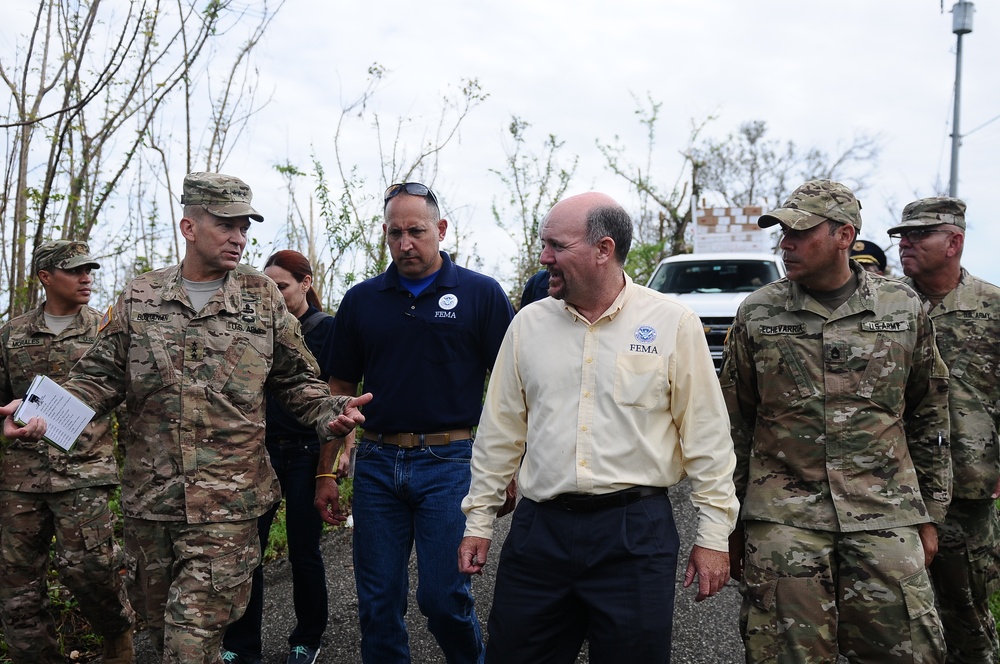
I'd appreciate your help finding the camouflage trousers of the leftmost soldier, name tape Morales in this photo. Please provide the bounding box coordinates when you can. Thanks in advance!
[0,486,133,664]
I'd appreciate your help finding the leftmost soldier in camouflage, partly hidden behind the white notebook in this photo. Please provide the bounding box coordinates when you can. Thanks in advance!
[0,240,134,664]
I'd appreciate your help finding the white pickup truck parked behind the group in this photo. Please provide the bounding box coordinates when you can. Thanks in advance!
[646,253,785,372]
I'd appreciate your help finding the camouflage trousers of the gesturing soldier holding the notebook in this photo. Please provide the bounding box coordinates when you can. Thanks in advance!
[125,517,260,664]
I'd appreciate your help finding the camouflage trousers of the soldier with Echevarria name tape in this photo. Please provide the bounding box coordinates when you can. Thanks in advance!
[740,521,945,664]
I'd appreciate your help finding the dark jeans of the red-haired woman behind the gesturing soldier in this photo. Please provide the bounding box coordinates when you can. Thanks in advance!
[223,440,329,658]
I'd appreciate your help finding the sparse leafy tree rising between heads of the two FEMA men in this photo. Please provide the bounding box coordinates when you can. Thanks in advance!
[490,115,579,296]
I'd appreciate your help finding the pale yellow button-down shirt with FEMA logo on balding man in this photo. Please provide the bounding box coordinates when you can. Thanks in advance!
[462,275,739,551]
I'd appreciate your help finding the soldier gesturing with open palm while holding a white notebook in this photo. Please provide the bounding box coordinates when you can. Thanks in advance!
[0,173,371,664]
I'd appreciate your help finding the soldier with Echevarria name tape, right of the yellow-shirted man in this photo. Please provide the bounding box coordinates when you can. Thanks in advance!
[721,180,951,664]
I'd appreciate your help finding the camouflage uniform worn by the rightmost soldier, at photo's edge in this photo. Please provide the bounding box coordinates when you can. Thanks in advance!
[904,269,1000,664]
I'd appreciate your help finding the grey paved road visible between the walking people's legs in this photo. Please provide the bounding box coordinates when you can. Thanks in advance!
[137,484,743,664]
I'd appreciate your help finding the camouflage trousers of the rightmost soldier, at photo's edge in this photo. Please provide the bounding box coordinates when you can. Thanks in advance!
[931,499,1000,664]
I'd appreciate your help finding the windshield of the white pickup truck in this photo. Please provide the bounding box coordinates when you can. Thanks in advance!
[649,260,781,293]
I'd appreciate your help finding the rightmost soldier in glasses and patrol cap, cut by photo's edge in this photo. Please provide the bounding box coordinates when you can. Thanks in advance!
[889,197,1000,664]
